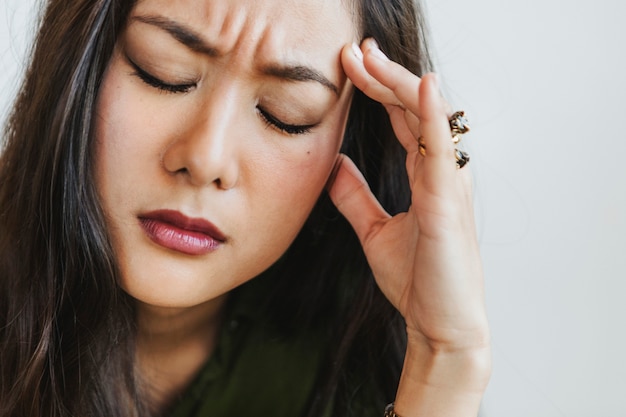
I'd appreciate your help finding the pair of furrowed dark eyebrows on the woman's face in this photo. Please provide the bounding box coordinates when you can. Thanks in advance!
[133,16,339,95]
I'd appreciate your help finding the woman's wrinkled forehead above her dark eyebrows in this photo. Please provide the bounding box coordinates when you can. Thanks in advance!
[132,0,357,60]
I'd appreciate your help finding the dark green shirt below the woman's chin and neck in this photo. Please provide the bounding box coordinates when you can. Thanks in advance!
[171,286,325,417]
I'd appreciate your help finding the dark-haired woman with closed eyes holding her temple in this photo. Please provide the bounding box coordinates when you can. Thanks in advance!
[0,0,489,417]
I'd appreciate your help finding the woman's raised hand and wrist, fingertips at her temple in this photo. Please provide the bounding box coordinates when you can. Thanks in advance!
[329,39,490,417]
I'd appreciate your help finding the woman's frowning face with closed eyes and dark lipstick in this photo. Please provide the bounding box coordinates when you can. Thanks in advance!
[95,0,355,307]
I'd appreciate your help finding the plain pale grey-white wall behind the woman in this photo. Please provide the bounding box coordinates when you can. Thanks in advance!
[0,0,626,417]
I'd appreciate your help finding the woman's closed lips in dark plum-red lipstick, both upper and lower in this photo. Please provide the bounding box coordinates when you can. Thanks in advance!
[139,210,226,255]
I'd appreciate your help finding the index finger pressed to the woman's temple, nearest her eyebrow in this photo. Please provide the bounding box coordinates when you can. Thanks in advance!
[341,44,401,106]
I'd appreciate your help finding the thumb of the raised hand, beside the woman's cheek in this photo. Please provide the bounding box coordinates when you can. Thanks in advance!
[328,155,390,244]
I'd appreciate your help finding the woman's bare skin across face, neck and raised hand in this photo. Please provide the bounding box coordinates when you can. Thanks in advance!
[96,0,489,417]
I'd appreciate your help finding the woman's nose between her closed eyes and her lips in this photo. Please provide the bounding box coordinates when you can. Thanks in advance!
[163,91,239,189]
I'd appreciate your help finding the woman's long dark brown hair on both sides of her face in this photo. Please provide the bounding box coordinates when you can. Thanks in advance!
[0,0,431,417]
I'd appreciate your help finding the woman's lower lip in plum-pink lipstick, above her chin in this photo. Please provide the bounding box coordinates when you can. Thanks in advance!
[140,218,222,255]
